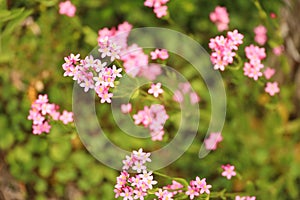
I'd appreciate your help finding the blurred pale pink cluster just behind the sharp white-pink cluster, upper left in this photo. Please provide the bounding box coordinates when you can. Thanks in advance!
[98,22,168,80]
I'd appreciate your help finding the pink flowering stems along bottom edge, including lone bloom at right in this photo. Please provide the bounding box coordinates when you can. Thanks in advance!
[114,149,255,200]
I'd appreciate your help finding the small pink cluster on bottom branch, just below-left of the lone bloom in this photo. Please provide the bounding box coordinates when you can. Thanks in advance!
[185,176,212,199]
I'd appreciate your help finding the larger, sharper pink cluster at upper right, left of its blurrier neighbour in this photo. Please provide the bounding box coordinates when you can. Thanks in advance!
[209,30,244,71]
